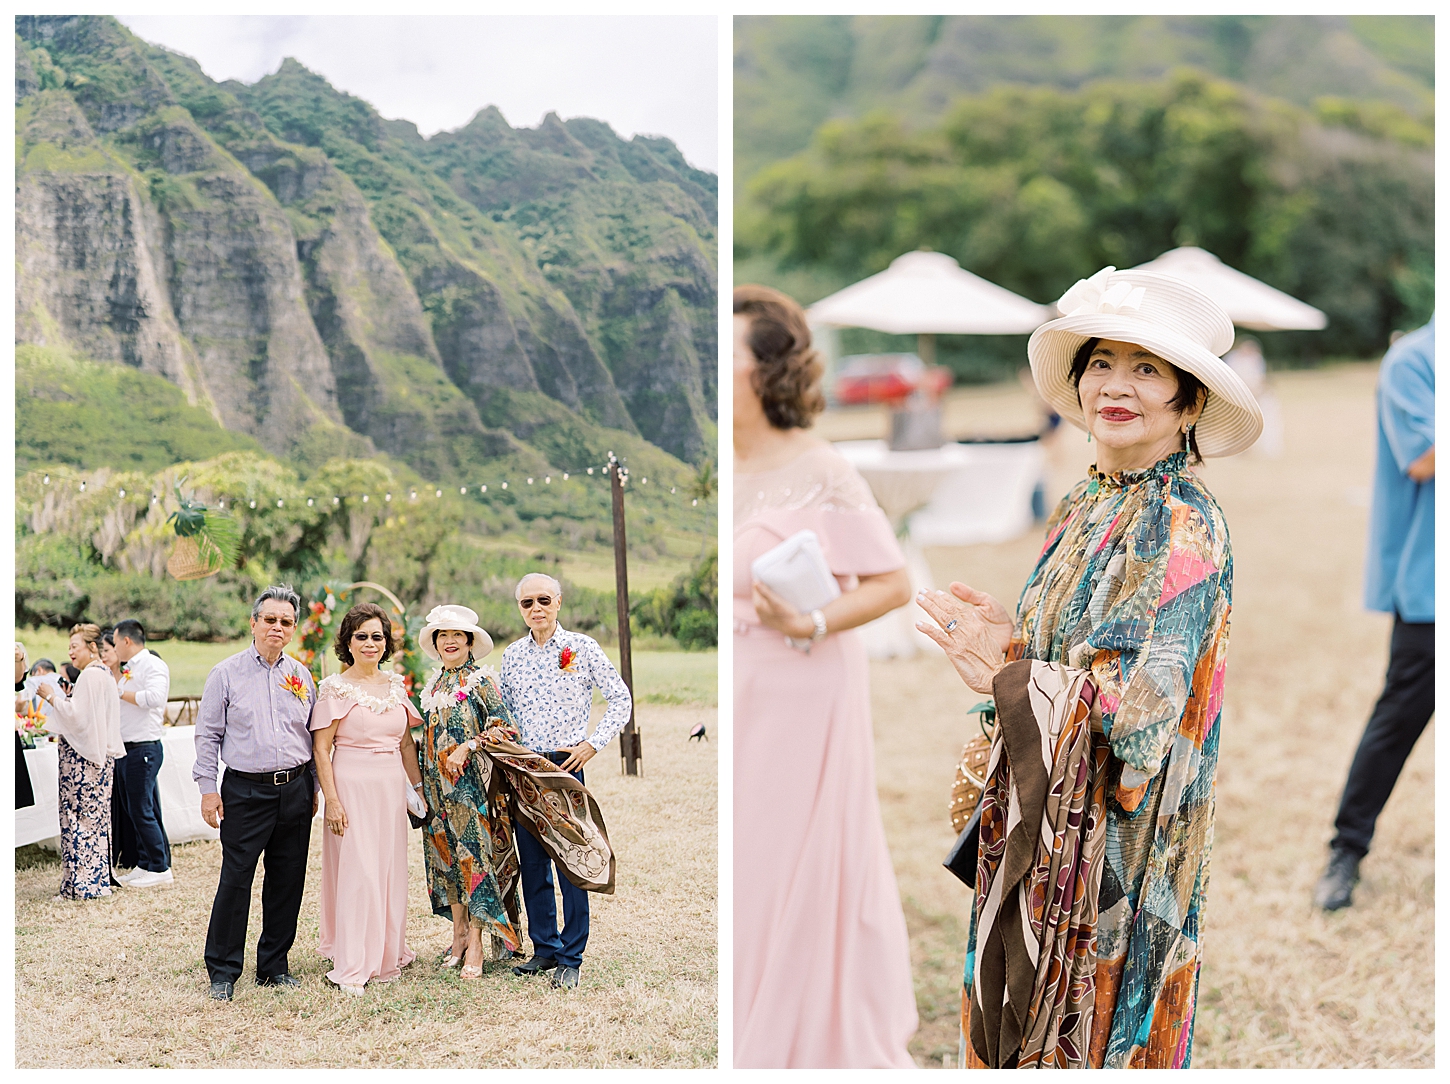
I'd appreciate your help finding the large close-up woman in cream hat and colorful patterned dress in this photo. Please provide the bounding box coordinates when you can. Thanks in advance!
[918,268,1262,1068]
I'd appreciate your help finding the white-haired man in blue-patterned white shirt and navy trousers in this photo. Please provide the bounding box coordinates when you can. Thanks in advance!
[500,572,632,987]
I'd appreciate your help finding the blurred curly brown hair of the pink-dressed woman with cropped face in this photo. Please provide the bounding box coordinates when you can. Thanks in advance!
[735,285,825,429]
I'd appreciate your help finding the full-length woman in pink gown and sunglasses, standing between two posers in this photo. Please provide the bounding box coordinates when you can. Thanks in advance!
[312,603,422,994]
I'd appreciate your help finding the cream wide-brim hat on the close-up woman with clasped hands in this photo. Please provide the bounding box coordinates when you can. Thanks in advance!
[1027,267,1264,458]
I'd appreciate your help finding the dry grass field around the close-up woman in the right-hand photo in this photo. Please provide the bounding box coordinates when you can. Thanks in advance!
[828,365,1434,1068]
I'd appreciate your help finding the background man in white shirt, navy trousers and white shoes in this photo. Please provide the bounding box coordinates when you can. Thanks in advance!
[115,619,171,888]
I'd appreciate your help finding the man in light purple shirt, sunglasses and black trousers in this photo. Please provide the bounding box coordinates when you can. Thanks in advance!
[191,584,318,1001]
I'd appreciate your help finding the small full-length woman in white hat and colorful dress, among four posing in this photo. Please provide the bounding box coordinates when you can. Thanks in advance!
[419,606,522,978]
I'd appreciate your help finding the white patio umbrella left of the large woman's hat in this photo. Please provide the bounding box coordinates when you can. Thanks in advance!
[806,252,1057,364]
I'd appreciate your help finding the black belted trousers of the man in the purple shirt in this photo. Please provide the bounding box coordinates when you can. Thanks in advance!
[206,771,312,983]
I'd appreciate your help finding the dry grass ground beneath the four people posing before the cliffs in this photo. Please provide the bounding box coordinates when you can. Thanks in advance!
[15,704,718,1070]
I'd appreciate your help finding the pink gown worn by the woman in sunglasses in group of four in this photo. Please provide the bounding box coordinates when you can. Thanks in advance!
[312,674,422,985]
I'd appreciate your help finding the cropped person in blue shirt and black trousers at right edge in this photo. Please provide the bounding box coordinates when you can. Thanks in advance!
[1314,316,1436,912]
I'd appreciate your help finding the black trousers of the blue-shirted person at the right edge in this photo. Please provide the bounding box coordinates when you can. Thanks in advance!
[1330,614,1436,858]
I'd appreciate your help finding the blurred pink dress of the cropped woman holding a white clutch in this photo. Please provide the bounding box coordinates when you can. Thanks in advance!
[734,446,916,1068]
